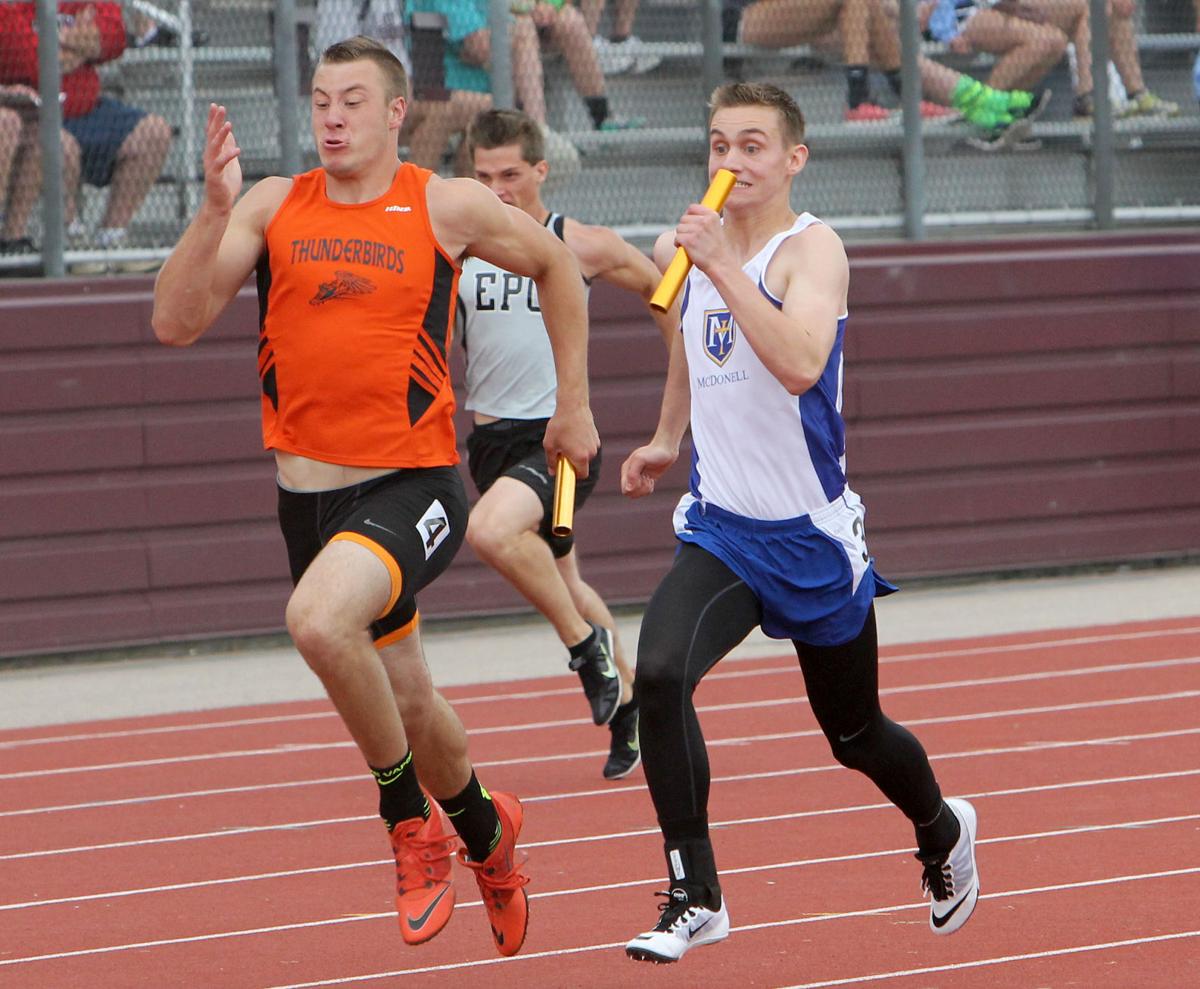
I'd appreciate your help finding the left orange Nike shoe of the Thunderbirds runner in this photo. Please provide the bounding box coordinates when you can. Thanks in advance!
[389,799,458,945]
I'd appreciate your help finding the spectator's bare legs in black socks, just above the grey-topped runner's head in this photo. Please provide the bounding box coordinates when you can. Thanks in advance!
[511,0,644,131]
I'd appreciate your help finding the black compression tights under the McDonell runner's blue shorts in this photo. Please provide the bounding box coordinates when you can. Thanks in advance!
[635,544,942,841]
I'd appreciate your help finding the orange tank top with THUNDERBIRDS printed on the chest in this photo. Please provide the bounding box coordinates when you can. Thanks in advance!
[258,163,460,467]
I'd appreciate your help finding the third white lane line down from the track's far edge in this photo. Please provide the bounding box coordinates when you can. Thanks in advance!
[0,690,1200,817]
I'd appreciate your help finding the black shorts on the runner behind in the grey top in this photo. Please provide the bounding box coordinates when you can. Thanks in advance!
[467,419,600,559]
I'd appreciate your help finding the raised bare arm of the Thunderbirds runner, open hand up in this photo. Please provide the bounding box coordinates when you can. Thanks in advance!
[150,106,292,347]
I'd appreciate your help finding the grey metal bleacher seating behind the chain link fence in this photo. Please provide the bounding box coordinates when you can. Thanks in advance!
[106,0,1200,245]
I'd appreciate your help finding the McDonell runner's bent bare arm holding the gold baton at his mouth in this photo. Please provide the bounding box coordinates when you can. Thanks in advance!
[674,204,850,395]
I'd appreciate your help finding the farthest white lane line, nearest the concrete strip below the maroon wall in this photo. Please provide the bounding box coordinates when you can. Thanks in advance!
[0,625,1200,749]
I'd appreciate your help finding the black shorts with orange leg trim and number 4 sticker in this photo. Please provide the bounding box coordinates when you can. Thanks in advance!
[278,467,467,647]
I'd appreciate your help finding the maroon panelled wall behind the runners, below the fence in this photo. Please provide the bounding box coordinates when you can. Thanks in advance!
[0,233,1200,655]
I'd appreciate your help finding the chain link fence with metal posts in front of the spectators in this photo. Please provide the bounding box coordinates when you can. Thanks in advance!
[0,0,1200,275]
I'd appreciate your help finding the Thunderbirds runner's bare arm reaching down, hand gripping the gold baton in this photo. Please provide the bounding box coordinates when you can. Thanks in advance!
[427,178,600,478]
